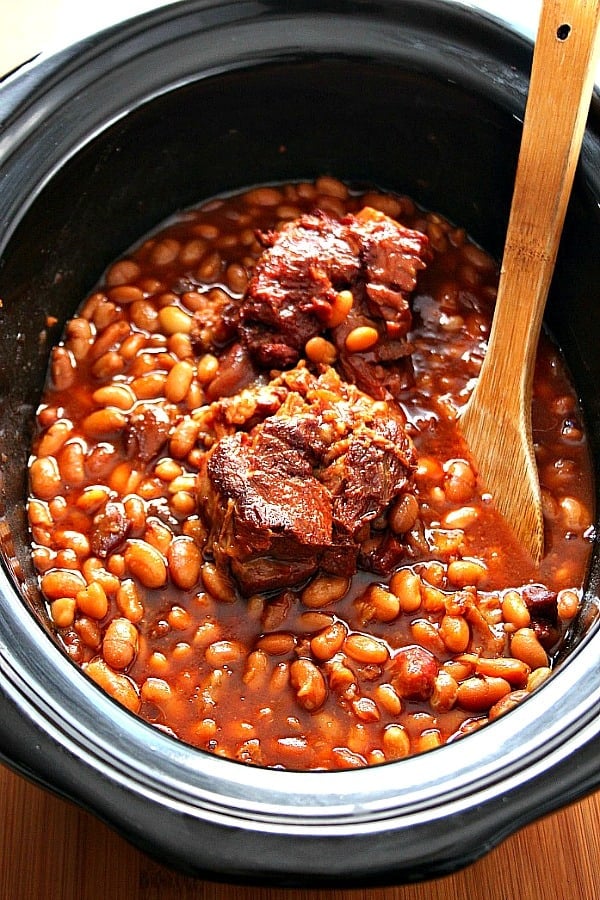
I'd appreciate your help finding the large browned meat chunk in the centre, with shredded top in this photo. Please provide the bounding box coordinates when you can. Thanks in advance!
[198,367,414,595]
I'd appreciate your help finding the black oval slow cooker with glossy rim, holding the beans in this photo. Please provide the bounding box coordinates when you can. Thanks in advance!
[0,0,600,886]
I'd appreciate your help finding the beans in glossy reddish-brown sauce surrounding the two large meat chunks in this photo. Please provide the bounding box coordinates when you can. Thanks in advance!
[29,177,593,769]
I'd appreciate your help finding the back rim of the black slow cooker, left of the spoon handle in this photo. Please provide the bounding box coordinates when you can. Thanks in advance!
[0,0,532,246]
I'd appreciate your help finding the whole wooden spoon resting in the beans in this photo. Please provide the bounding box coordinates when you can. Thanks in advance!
[460,0,600,564]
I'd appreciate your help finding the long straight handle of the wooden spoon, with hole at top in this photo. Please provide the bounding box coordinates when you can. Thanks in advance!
[488,0,600,414]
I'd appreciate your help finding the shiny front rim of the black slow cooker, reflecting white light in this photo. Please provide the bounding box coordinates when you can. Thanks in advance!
[0,552,600,833]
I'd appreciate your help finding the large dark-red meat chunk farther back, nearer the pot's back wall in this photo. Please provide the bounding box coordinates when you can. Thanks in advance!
[240,208,431,397]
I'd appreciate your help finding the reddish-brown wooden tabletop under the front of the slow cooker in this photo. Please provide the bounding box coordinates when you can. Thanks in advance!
[0,768,600,900]
